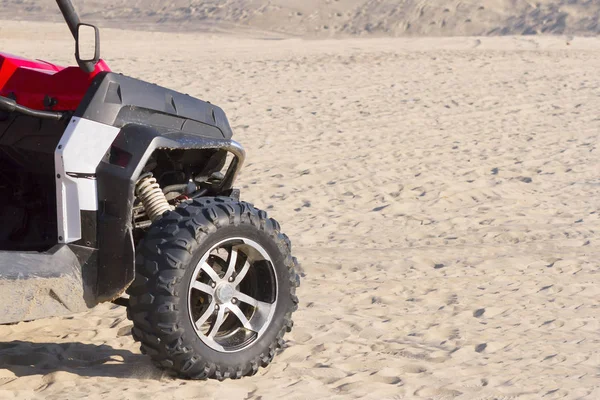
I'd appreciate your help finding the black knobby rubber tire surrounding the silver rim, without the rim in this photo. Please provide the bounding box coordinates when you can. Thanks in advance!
[127,197,300,380]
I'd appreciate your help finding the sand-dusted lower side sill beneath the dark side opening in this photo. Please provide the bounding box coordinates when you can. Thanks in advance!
[0,245,96,324]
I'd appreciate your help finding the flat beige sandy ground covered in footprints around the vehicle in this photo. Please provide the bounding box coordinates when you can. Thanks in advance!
[0,22,600,400]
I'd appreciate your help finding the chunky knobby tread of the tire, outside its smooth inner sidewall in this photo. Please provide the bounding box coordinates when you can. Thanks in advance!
[127,197,299,381]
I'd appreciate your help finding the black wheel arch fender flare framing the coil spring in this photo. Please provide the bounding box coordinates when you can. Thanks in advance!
[96,124,245,302]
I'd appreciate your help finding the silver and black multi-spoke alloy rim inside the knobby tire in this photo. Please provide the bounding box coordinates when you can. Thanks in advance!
[188,237,279,353]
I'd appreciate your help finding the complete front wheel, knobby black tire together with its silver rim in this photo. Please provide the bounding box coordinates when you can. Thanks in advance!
[128,197,299,380]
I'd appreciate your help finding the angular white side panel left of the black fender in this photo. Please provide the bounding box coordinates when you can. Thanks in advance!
[54,118,120,243]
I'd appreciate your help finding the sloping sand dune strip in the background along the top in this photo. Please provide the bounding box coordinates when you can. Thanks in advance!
[0,0,600,37]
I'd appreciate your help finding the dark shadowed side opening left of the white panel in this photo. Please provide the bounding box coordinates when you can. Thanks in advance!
[0,113,66,251]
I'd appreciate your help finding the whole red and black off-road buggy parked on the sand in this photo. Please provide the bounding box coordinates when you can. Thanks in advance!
[0,0,299,380]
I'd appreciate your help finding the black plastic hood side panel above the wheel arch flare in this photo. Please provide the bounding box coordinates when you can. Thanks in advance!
[75,72,232,139]
